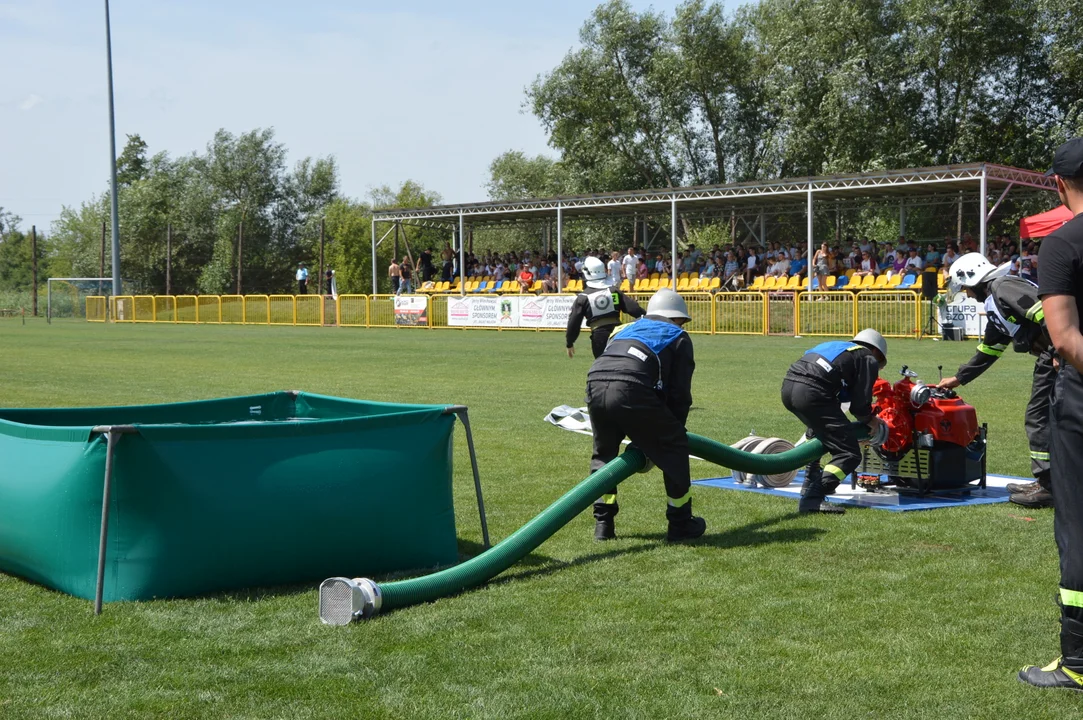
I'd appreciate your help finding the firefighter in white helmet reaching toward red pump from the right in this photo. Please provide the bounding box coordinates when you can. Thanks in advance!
[940,252,1057,508]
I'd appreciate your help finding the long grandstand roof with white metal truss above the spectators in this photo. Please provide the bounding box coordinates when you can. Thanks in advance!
[373,162,1056,227]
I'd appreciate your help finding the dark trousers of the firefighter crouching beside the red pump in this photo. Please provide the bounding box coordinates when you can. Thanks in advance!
[782,378,861,498]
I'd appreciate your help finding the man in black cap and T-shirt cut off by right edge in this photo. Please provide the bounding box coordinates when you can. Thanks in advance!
[1019,138,1083,691]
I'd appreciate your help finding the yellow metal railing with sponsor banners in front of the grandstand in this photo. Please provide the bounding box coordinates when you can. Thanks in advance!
[93,288,925,338]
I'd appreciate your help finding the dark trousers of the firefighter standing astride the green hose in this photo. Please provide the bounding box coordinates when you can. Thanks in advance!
[587,380,692,520]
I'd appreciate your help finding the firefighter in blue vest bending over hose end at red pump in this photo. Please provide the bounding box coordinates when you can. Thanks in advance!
[782,329,887,514]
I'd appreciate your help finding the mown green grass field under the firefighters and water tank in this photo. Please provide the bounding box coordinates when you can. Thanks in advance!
[0,319,1080,719]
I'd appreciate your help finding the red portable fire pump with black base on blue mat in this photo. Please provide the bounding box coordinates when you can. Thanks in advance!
[853,366,987,495]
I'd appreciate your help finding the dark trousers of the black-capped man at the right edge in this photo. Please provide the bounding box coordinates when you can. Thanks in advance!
[1049,364,1083,672]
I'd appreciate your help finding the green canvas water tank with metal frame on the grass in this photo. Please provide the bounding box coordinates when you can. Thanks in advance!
[0,393,457,601]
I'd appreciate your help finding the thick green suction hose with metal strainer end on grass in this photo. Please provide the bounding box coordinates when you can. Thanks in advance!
[319,423,867,625]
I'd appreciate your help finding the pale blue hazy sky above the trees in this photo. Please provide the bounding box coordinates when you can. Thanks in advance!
[0,0,738,230]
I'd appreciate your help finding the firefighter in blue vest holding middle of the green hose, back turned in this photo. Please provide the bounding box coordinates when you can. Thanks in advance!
[587,288,707,541]
